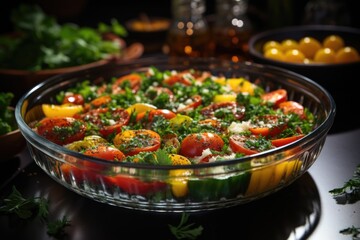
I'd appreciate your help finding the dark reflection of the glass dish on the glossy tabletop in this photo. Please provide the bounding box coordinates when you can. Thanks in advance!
[0,151,320,240]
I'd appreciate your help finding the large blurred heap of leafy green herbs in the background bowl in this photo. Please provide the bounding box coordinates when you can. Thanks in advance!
[0,4,127,71]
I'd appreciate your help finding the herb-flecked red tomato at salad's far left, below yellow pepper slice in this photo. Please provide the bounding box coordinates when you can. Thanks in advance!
[37,117,86,145]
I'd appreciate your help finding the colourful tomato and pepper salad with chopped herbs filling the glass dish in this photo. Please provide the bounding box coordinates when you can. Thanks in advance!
[34,67,314,165]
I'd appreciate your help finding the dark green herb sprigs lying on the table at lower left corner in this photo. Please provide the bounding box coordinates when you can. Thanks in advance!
[0,186,70,237]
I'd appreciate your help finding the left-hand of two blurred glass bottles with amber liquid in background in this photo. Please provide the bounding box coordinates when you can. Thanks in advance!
[165,0,211,57]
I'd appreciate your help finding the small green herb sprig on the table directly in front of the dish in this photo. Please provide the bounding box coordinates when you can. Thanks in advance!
[169,212,203,239]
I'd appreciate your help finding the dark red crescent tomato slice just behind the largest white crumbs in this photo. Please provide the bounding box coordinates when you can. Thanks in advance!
[201,102,245,120]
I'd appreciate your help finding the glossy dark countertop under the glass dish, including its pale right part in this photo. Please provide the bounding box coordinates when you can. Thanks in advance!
[0,124,360,240]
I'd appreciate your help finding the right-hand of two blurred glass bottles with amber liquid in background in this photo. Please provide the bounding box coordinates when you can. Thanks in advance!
[212,0,253,62]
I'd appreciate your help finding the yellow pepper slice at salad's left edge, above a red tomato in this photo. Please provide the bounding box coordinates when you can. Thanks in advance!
[42,103,84,117]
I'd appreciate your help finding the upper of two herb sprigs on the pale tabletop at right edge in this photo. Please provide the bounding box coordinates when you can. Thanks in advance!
[329,165,360,203]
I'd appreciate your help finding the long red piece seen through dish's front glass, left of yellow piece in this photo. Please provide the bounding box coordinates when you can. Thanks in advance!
[104,175,167,196]
